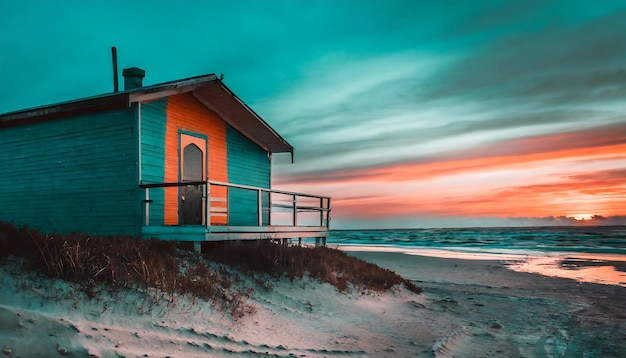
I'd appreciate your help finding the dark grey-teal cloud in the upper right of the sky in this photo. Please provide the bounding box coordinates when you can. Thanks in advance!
[425,8,626,106]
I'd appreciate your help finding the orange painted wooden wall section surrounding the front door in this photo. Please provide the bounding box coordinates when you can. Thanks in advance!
[164,93,228,225]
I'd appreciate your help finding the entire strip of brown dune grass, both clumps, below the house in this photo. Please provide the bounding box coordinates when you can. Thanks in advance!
[0,223,421,318]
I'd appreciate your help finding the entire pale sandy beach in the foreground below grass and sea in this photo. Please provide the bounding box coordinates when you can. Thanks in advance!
[0,250,626,357]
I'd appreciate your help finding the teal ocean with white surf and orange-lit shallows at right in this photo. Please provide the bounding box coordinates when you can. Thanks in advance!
[326,226,626,287]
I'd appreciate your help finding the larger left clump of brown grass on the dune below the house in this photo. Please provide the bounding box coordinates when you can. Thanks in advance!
[0,223,251,318]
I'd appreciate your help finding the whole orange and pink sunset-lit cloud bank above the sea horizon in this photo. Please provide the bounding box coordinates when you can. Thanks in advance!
[276,126,626,220]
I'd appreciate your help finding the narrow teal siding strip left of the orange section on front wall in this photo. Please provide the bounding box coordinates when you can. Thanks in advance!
[141,98,167,225]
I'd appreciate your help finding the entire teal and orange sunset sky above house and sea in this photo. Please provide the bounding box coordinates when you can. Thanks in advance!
[0,0,626,229]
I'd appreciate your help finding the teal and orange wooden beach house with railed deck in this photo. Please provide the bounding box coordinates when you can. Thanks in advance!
[0,68,330,247]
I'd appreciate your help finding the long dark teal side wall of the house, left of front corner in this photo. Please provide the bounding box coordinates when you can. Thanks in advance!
[0,109,140,235]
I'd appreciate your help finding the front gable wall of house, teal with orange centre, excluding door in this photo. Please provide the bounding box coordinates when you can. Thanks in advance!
[141,94,270,226]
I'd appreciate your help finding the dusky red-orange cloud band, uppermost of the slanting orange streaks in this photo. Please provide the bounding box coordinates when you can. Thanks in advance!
[275,123,626,184]
